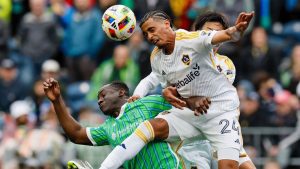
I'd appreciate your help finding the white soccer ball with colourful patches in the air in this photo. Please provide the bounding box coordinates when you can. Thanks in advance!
[102,5,136,41]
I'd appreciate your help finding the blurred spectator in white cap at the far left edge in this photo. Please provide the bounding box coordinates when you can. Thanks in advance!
[0,100,33,169]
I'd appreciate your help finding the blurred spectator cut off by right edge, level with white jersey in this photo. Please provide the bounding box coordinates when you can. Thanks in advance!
[280,44,300,94]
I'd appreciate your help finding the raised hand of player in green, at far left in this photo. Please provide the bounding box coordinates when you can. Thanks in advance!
[43,78,61,101]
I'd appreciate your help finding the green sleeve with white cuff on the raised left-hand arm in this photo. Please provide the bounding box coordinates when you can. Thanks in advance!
[86,123,109,146]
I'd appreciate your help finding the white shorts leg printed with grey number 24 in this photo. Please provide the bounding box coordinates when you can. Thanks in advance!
[200,110,243,161]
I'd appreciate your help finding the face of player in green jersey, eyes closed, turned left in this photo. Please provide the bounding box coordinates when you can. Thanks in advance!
[98,85,120,116]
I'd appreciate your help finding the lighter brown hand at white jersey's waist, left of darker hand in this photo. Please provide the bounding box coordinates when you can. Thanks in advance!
[162,86,186,109]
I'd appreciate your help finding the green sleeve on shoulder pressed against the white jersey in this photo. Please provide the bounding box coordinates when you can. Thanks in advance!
[139,95,172,116]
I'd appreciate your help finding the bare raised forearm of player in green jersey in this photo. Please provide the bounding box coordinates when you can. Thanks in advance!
[52,97,91,144]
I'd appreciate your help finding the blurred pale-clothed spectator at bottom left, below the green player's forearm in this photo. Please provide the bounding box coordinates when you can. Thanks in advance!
[18,106,64,169]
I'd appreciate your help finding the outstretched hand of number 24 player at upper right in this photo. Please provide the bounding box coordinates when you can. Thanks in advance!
[235,11,254,32]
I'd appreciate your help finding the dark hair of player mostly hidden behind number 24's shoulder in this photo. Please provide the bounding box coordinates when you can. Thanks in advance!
[193,11,229,30]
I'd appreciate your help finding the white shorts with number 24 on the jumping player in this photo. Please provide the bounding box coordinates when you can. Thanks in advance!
[156,108,243,161]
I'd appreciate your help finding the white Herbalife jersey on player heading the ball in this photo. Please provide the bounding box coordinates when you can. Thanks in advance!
[151,29,239,116]
